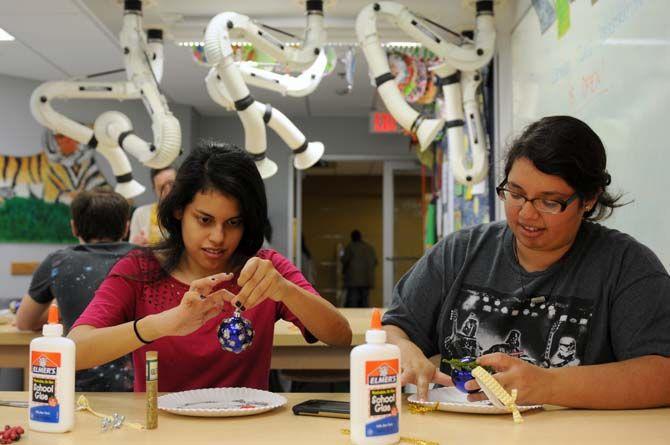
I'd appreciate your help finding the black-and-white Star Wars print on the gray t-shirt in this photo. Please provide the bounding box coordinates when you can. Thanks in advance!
[441,286,593,372]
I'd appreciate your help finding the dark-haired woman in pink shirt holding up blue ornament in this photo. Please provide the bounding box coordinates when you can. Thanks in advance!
[69,142,351,391]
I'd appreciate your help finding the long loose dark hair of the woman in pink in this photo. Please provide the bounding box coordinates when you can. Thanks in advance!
[152,140,267,273]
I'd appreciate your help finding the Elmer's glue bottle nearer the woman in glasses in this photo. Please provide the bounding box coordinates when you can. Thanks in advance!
[350,308,401,445]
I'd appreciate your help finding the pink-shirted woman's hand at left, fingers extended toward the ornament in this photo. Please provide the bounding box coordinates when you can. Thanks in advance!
[159,273,235,336]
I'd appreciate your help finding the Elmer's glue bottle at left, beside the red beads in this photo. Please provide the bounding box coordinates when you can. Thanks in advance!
[28,305,75,433]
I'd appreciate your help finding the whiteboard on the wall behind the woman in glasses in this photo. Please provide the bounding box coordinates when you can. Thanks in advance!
[512,0,670,269]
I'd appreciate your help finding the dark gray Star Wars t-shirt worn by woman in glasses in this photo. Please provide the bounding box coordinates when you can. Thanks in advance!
[383,221,670,373]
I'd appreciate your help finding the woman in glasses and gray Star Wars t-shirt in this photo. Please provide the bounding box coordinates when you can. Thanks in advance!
[383,116,670,409]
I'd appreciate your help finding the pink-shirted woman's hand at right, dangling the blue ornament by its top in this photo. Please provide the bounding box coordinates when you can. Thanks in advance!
[231,257,291,310]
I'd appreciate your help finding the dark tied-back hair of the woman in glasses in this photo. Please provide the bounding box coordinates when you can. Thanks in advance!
[505,116,627,221]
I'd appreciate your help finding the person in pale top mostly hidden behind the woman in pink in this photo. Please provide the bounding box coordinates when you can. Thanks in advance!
[129,167,177,246]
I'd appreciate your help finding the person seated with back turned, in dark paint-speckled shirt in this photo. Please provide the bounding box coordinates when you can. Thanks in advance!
[16,189,134,391]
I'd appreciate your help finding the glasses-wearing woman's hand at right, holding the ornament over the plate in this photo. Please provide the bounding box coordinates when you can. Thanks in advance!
[465,352,553,405]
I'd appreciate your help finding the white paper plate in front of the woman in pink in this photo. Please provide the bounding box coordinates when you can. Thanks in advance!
[158,388,286,417]
